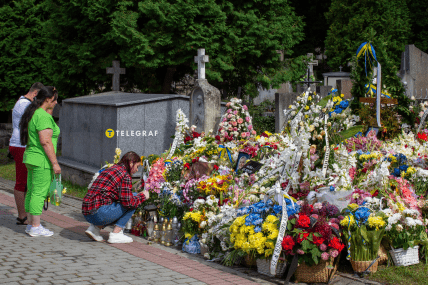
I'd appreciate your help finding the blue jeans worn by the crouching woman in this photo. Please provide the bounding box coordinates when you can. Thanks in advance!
[84,194,136,226]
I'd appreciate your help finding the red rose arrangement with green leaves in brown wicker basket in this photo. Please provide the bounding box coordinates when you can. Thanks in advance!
[282,203,345,283]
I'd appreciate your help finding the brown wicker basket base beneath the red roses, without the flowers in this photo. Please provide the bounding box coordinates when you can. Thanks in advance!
[294,260,337,283]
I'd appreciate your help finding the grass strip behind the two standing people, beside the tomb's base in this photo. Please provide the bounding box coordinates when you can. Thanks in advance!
[0,148,88,198]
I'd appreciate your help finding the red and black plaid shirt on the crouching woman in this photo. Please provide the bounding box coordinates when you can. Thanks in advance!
[82,164,145,215]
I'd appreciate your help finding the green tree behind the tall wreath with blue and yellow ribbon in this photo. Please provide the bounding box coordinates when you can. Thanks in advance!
[326,0,413,122]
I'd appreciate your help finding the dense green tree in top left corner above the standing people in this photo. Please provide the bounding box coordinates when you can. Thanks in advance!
[0,0,50,111]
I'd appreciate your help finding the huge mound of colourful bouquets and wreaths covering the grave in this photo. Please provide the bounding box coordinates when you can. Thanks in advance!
[94,83,428,282]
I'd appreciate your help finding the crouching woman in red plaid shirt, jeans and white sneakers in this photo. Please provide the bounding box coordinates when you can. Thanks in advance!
[82,151,149,243]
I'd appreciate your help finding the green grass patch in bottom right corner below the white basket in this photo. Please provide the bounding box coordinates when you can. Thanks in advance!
[367,263,428,285]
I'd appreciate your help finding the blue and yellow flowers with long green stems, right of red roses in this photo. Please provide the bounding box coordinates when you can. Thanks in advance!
[340,203,386,272]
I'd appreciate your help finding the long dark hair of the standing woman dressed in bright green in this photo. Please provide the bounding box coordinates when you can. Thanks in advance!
[19,86,55,145]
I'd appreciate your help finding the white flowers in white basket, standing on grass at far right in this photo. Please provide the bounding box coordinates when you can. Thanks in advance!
[384,209,425,266]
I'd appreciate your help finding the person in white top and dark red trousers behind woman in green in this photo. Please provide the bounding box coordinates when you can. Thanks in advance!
[9,82,43,225]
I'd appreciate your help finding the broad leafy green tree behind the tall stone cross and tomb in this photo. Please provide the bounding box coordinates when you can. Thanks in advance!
[105,0,303,97]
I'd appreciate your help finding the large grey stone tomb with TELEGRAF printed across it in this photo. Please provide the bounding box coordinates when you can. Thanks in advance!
[58,91,226,186]
